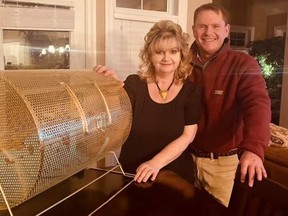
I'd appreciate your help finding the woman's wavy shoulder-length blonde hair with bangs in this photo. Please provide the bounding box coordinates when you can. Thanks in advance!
[138,20,192,81]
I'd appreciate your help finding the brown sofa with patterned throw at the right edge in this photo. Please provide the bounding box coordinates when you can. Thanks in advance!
[264,123,288,188]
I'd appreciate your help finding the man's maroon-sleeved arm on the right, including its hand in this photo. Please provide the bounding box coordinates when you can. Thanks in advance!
[238,58,271,187]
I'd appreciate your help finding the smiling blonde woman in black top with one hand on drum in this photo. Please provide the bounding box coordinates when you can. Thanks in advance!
[94,20,200,182]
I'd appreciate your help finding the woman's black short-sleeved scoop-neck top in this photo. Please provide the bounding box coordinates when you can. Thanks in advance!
[119,74,201,182]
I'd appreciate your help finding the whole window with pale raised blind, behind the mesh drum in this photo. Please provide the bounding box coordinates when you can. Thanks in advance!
[0,0,75,70]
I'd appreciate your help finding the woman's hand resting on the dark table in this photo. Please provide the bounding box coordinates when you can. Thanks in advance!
[134,160,160,183]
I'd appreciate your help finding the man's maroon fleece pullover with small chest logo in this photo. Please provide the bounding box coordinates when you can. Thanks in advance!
[191,40,271,160]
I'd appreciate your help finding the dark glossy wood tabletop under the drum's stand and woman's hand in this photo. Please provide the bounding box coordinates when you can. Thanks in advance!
[0,169,233,216]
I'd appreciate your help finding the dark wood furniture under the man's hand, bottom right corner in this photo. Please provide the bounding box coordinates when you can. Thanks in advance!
[229,172,288,216]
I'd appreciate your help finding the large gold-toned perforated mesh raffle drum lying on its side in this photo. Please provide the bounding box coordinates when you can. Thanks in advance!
[0,69,132,210]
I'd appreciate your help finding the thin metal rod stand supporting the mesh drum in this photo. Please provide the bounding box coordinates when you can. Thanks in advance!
[0,151,134,216]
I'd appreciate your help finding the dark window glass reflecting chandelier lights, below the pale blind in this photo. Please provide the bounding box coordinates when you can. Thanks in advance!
[3,30,70,70]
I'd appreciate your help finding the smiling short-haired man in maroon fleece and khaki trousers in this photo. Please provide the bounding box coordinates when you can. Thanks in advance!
[190,3,271,206]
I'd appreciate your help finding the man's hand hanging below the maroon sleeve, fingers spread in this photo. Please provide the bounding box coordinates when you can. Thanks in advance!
[240,151,267,187]
